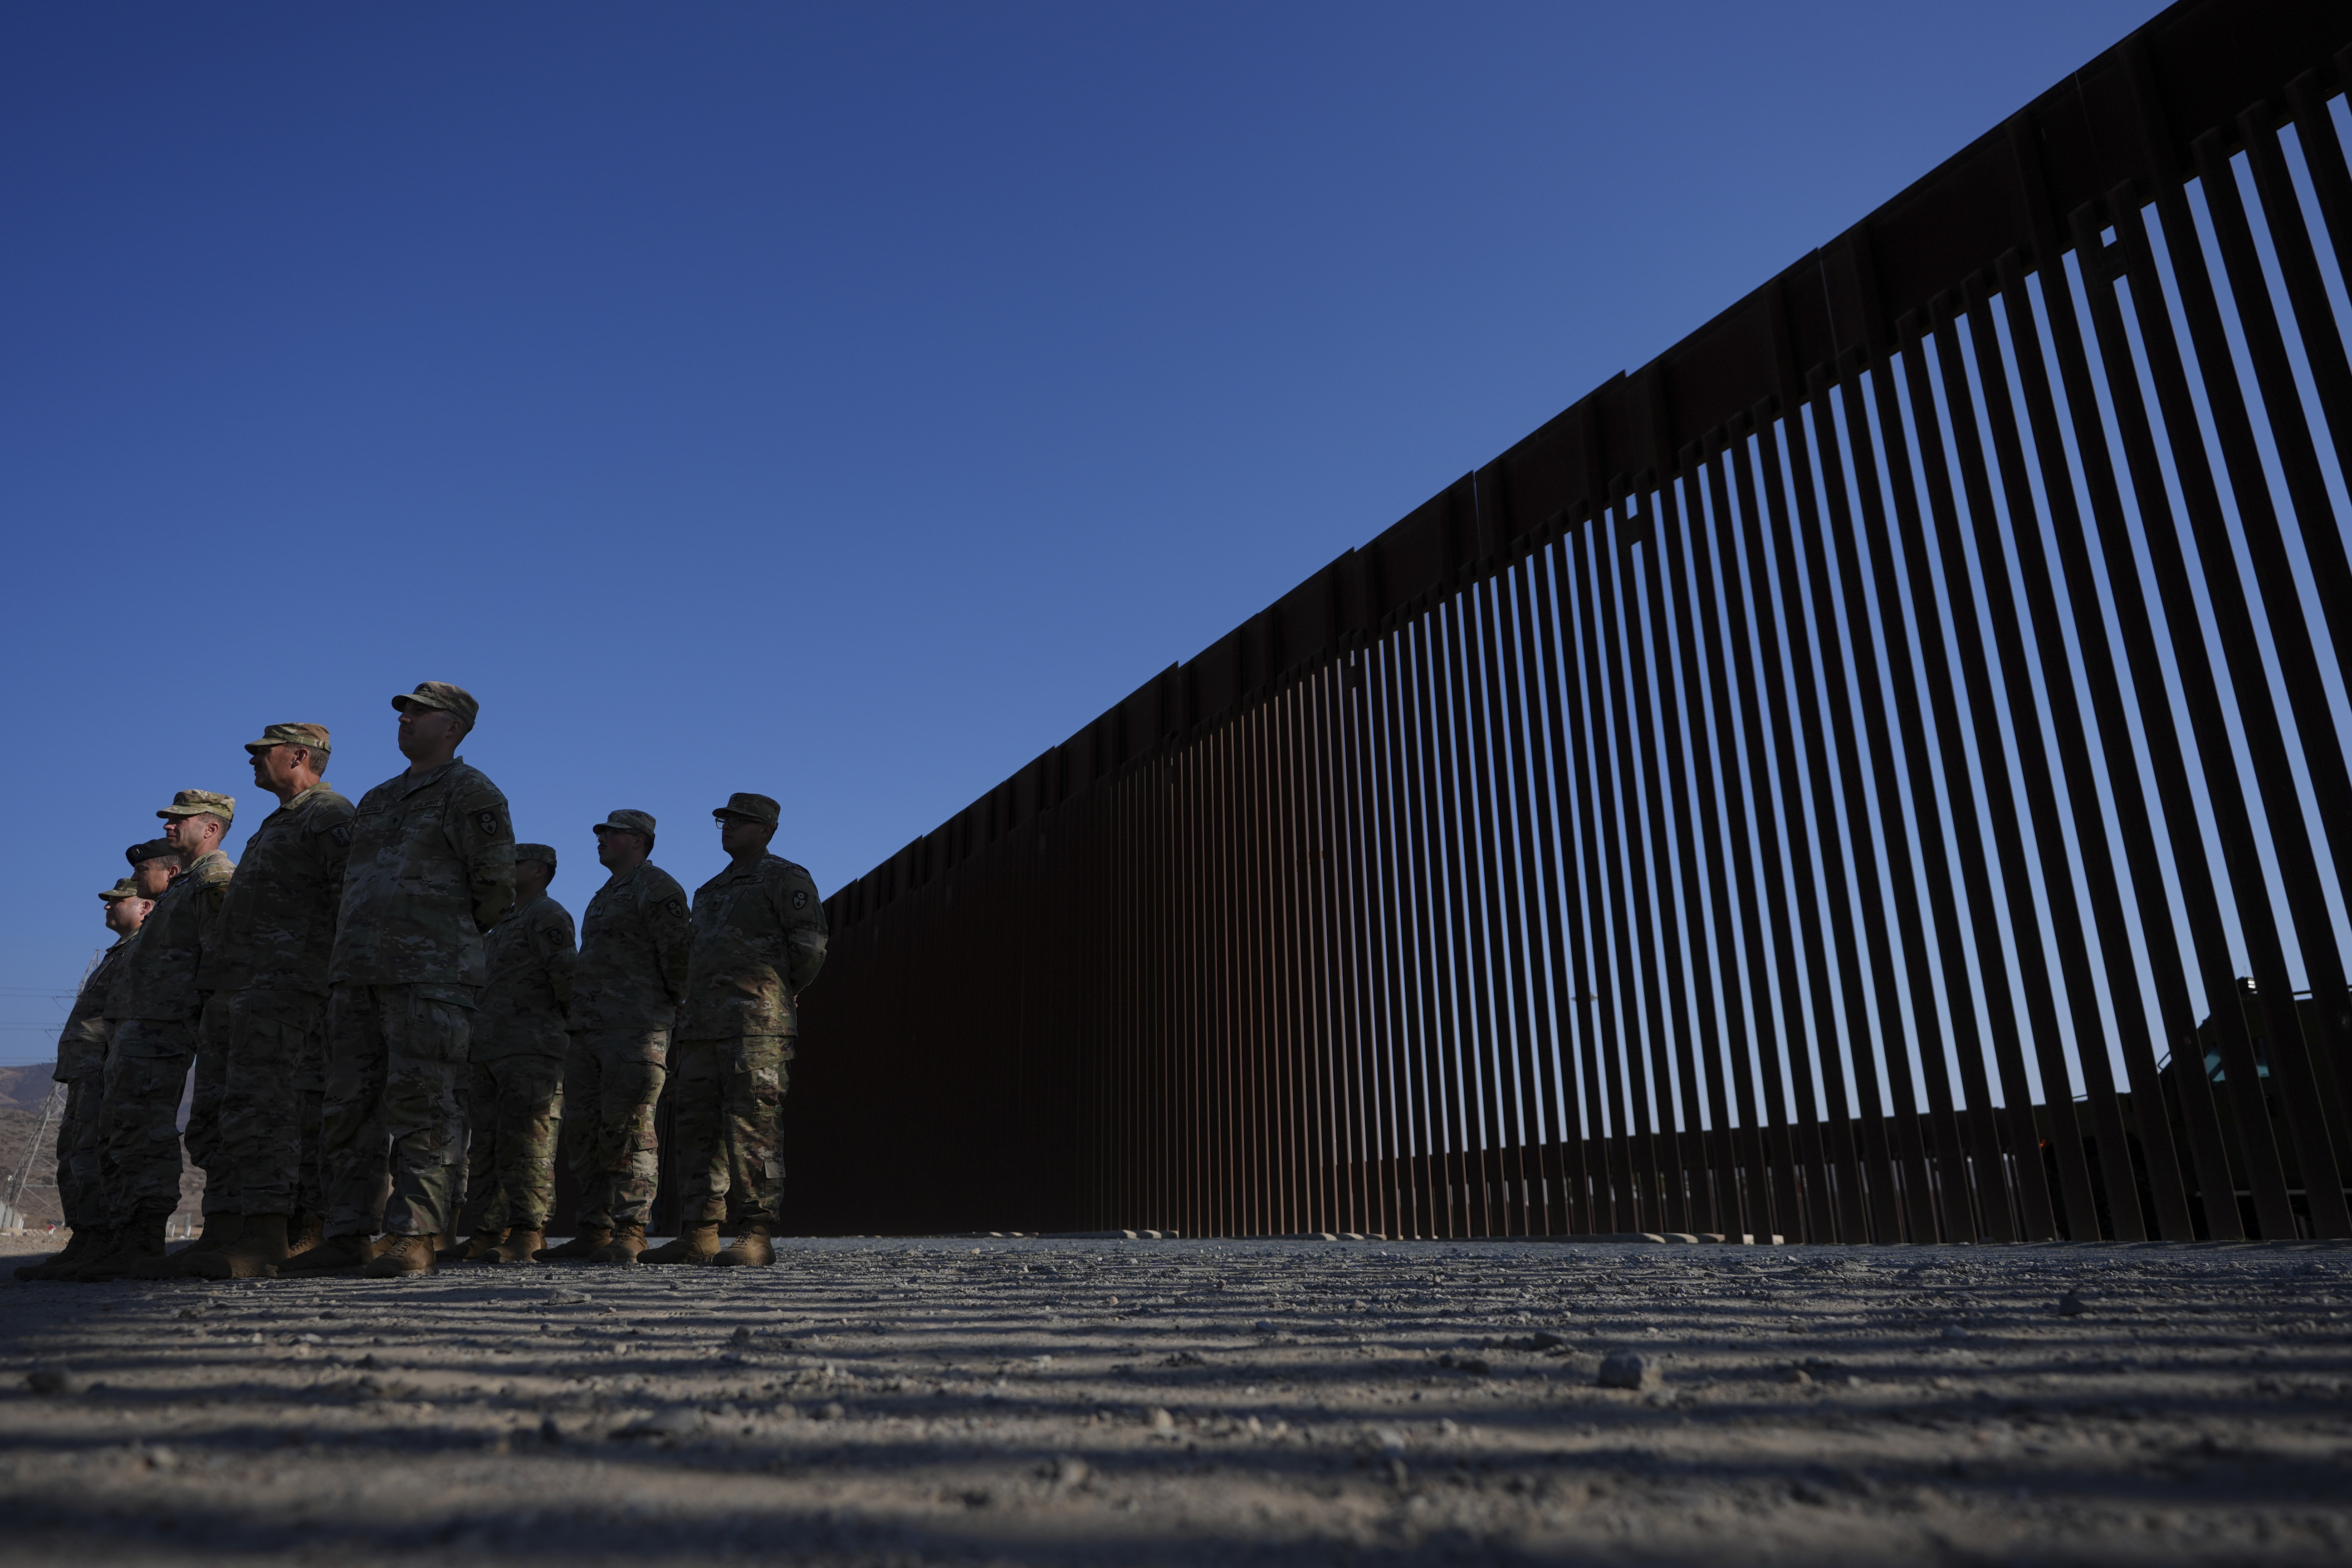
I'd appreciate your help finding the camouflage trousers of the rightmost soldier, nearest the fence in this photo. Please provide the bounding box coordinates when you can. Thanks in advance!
[673,1034,792,1225]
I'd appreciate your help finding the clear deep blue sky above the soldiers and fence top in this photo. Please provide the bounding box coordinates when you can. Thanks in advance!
[0,0,2157,1060]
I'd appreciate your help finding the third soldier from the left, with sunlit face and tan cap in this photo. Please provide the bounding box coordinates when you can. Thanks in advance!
[73,790,238,1281]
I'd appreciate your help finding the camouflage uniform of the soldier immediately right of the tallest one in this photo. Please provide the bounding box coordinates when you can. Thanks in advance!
[466,884,576,1232]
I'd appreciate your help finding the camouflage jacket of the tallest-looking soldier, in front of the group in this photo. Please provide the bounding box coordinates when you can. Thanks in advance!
[327,757,515,987]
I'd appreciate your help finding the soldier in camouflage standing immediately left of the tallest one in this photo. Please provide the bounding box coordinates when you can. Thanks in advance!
[179,724,353,1279]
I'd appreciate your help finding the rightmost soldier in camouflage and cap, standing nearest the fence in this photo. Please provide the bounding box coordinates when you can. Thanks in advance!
[645,795,826,1265]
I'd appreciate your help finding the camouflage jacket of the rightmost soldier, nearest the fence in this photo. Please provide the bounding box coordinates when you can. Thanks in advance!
[677,856,826,1039]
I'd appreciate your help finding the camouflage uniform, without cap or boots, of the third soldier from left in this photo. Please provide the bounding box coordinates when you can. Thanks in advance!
[101,841,238,1225]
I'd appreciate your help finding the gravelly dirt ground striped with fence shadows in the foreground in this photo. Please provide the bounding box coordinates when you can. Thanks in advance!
[0,1236,2352,1566]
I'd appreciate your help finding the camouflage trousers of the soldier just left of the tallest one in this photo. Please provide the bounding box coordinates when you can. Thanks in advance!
[210,990,327,1218]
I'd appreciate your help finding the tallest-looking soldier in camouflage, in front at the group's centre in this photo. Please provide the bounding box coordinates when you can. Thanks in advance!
[278,682,515,1279]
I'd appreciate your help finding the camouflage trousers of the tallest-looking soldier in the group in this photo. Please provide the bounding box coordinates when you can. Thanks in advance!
[320,980,473,1236]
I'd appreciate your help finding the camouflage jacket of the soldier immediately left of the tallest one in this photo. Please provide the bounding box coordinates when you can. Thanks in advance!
[198,781,351,997]
